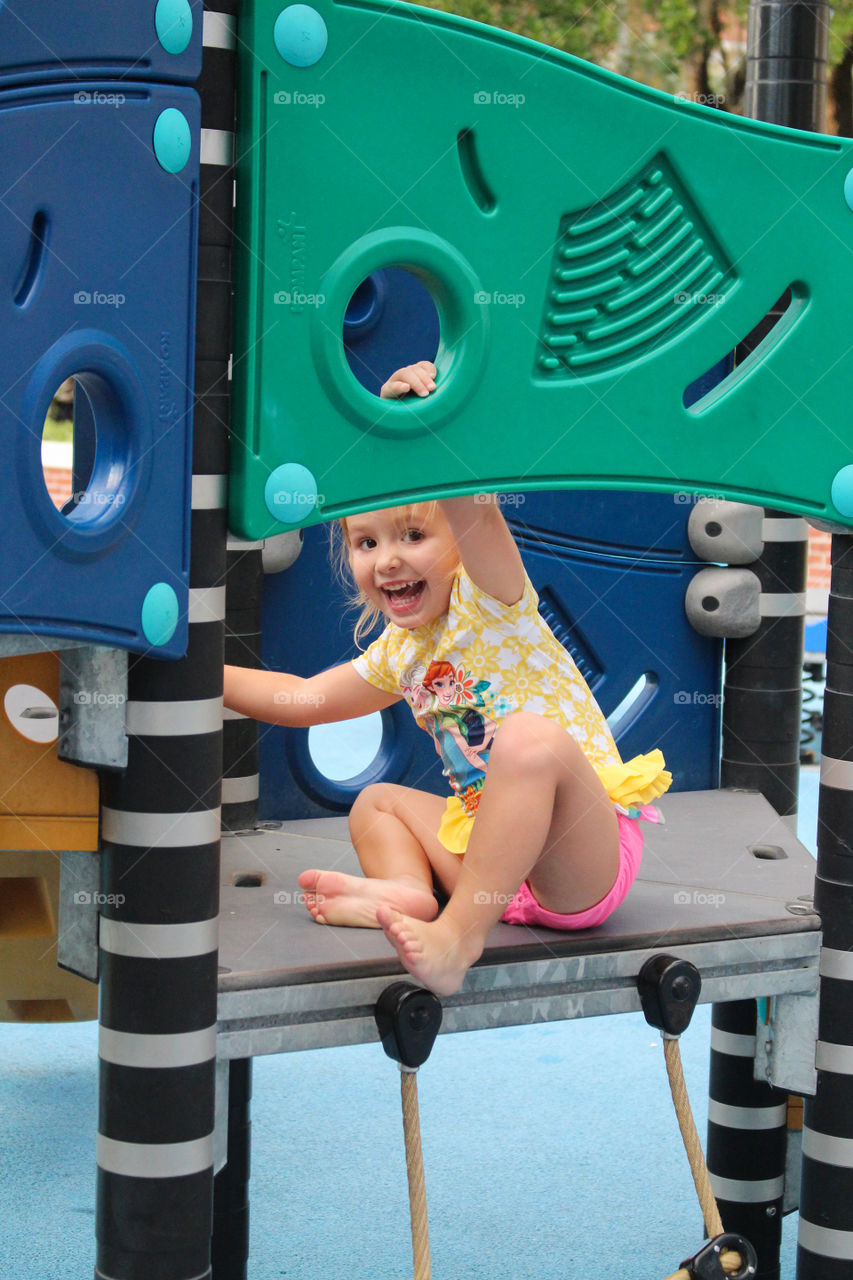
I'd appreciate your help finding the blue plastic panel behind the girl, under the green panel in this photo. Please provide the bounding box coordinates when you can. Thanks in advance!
[260,492,721,818]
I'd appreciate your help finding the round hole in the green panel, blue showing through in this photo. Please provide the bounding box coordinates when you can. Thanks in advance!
[343,266,441,396]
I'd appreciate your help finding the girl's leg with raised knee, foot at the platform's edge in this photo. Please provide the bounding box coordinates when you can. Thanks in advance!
[377,712,619,995]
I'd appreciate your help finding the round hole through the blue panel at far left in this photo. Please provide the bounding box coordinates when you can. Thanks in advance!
[41,372,129,527]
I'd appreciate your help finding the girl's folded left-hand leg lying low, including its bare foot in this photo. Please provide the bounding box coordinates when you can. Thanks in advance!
[300,782,460,928]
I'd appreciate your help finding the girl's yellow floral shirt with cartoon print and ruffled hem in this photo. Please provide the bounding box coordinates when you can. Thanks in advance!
[353,568,670,814]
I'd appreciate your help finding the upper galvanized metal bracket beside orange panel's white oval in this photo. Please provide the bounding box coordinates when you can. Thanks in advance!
[56,645,127,769]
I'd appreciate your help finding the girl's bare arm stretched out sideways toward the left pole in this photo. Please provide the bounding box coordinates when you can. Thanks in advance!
[224,662,400,728]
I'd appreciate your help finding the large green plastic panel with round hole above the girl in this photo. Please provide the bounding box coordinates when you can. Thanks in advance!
[231,0,853,538]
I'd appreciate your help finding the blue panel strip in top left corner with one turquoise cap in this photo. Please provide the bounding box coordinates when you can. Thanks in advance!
[0,0,204,88]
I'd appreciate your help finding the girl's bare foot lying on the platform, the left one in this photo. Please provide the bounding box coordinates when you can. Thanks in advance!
[300,870,438,929]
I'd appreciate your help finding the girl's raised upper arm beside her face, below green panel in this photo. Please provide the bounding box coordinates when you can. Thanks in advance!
[442,493,524,604]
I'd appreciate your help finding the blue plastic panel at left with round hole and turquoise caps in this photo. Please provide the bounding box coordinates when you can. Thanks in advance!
[0,82,200,657]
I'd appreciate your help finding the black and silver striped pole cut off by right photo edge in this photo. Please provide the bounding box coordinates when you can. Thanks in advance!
[797,534,853,1280]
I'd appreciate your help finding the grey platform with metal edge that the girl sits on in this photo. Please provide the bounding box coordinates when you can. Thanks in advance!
[218,791,821,1057]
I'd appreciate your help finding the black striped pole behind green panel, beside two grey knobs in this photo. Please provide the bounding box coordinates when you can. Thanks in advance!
[708,0,829,1280]
